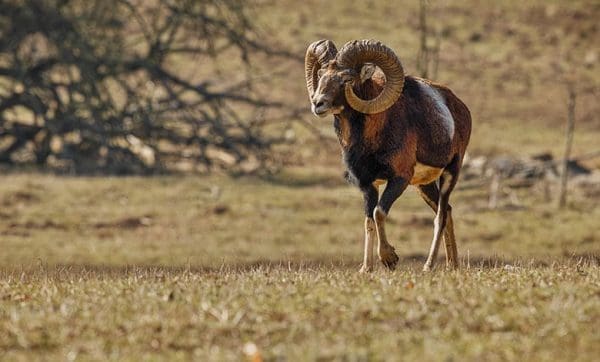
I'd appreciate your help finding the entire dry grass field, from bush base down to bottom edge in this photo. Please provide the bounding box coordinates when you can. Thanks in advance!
[0,171,600,361]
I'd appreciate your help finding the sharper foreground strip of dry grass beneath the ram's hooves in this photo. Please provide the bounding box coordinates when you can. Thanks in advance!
[0,260,600,361]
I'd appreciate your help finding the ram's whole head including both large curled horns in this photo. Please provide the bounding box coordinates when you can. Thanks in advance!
[304,40,404,117]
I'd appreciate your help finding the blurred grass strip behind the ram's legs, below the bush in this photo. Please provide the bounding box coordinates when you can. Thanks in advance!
[0,169,600,266]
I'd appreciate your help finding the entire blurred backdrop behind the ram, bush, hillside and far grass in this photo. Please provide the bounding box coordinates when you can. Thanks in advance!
[0,0,600,265]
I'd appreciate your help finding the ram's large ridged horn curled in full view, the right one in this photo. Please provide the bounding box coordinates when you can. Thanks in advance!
[337,39,404,114]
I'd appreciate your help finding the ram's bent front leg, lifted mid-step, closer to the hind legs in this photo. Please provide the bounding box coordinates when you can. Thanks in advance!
[373,177,408,270]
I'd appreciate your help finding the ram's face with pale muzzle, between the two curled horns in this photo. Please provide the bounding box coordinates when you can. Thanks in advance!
[311,61,356,117]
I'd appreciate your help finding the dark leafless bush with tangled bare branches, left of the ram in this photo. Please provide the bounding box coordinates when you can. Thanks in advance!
[0,0,286,173]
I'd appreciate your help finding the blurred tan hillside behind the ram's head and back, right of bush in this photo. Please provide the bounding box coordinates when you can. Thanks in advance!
[246,0,600,166]
